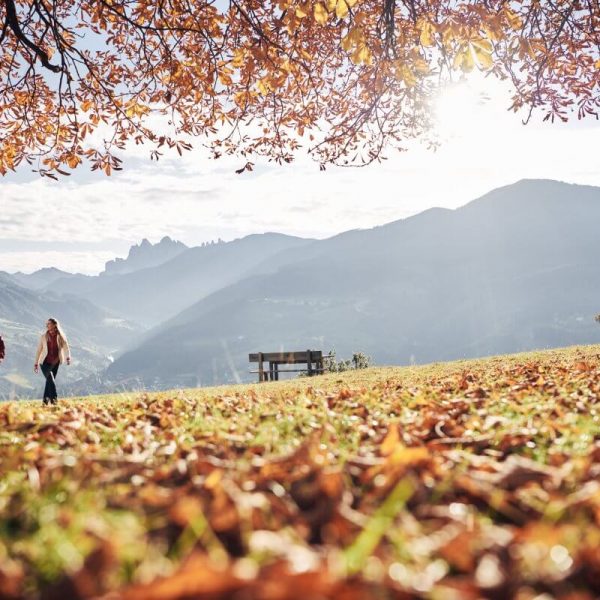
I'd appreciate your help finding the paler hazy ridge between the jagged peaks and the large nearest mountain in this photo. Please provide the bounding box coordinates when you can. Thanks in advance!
[48,233,312,326]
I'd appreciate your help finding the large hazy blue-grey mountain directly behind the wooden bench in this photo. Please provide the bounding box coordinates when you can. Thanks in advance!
[107,180,600,387]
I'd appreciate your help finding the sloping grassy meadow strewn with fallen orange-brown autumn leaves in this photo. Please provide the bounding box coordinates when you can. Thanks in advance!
[0,346,600,600]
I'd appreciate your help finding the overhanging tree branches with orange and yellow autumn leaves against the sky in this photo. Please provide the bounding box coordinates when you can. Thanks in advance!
[0,0,600,177]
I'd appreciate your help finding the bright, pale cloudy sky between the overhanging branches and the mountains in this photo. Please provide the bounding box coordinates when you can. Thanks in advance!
[0,72,600,274]
